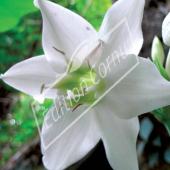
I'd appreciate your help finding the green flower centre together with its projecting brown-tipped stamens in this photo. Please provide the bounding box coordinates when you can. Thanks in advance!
[40,40,105,111]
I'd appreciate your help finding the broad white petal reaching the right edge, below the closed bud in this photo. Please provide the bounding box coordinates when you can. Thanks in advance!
[102,55,170,119]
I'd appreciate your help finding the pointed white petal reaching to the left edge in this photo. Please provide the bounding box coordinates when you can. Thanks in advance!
[2,55,56,98]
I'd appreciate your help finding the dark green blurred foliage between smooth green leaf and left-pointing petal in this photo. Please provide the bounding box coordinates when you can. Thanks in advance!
[0,12,43,73]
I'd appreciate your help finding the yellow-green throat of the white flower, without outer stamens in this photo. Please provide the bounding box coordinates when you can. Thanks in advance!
[55,65,104,111]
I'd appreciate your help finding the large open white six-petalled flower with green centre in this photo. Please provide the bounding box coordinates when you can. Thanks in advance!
[2,0,170,170]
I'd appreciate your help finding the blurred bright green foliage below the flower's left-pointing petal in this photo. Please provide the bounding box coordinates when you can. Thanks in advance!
[0,93,53,166]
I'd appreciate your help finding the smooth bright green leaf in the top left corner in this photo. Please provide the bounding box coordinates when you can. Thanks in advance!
[0,0,38,32]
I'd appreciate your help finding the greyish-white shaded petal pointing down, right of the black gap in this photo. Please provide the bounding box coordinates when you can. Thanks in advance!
[95,100,139,170]
